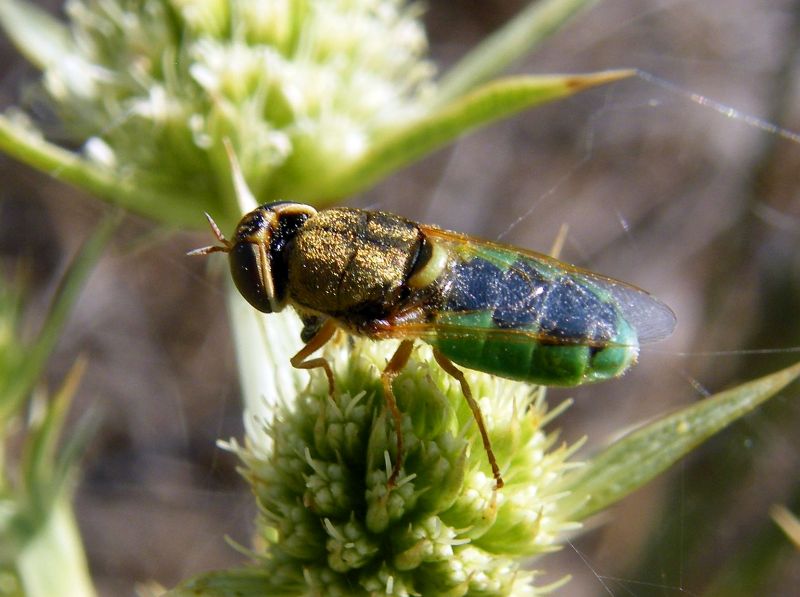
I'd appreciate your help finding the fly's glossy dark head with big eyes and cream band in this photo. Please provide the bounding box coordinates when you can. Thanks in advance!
[228,202,317,313]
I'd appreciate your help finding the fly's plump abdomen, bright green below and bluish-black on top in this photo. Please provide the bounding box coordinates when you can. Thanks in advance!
[429,252,638,385]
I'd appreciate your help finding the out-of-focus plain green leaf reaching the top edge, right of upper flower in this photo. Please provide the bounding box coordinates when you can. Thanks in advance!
[434,0,596,105]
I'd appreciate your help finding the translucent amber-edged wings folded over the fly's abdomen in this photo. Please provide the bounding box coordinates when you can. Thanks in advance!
[382,225,675,346]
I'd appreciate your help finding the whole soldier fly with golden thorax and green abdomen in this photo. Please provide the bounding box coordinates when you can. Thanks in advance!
[190,202,675,488]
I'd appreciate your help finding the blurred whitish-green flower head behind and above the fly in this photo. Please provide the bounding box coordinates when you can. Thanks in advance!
[44,0,433,218]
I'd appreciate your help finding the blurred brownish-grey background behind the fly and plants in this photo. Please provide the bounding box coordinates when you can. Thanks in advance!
[0,0,800,596]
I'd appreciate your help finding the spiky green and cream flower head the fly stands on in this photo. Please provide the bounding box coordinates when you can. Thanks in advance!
[225,324,577,595]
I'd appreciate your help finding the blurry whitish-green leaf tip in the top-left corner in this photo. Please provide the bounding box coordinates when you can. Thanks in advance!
[0,0,74,69]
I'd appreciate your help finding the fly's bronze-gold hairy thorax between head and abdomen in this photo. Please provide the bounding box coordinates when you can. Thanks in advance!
[289,208,422,315]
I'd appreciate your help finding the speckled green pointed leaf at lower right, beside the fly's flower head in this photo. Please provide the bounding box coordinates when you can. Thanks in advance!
[563,363,800,520]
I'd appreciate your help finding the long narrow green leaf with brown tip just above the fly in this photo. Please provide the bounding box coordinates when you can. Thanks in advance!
[310,70,634,200]
